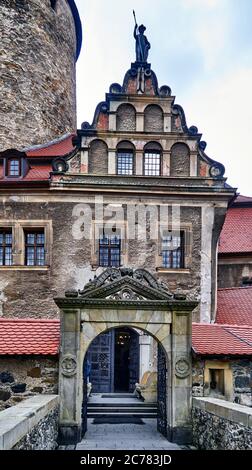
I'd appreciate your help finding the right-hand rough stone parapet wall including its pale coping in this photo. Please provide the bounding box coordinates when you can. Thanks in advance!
[192,397,252,450]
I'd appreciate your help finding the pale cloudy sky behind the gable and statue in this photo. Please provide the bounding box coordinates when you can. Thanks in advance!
[75,0,252,196]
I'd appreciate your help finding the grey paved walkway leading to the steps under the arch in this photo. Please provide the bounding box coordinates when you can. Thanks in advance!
[72,419,182,450]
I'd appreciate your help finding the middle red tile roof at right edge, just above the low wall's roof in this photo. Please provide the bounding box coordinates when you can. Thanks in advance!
[216,287,252,326]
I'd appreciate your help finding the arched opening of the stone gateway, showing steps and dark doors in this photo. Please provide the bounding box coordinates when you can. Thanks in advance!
[82,327,168,437]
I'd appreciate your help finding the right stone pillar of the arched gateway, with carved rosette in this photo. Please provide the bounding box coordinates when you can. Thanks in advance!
[167,311,192,444]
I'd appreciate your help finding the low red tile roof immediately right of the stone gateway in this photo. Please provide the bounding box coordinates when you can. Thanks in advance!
[192,323,252,356]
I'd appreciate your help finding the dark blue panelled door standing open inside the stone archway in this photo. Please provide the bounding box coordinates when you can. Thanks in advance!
[86,327,140,393]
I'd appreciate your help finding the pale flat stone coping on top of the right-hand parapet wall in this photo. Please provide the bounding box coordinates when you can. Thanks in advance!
[193,397,252,428]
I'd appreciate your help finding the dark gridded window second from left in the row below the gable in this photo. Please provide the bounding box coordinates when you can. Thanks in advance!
[25,230,45,266]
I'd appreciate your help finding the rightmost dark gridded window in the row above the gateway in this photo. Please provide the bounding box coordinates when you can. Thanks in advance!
[162,232,185,269]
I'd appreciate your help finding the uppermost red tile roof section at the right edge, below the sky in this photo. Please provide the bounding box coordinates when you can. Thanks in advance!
[219,206,252,254]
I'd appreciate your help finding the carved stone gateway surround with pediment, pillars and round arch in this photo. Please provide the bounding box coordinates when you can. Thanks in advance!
[55,268,197,444]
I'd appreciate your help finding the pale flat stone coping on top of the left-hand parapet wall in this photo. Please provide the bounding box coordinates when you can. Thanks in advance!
[0,395,59,450]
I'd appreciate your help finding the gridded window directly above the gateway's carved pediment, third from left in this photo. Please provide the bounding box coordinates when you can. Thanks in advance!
[99,232,121,268]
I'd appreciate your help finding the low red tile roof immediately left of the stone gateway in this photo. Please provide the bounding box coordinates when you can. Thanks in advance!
[0,318,60,356]
